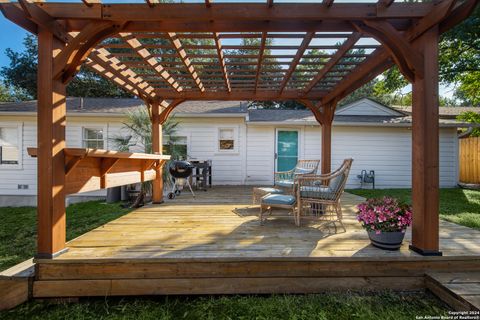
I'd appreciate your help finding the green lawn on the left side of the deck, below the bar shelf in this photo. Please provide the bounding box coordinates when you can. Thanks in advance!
[0,201,130,271]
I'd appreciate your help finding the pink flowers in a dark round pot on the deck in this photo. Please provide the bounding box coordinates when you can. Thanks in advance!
[357,197,412,250]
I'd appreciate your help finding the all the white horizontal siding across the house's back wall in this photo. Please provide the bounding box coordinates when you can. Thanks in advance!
[0,106,458,205]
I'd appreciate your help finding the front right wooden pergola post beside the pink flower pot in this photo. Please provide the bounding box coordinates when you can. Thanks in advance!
[410,26,441,255]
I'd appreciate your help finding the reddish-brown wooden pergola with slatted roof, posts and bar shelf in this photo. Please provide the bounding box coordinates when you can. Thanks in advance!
[0,0,478,258]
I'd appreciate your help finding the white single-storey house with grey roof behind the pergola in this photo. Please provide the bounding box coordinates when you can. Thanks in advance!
[0,98,465,206]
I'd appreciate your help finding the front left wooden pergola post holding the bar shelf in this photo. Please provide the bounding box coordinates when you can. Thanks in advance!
[37,27,66,258]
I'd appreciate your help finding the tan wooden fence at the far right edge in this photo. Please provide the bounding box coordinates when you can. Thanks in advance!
[459,137,480,184]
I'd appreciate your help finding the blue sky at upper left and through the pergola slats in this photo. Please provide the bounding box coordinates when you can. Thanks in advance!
[0,0,453,98]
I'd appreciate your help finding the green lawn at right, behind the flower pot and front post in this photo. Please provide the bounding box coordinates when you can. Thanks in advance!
[347,188,480,230]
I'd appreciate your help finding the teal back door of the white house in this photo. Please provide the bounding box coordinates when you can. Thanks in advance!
[277,130,298,171]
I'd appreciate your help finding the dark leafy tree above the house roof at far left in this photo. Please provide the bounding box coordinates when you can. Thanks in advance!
[0,35,131,100]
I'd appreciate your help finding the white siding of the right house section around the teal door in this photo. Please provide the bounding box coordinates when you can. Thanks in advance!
[247,125,458,188]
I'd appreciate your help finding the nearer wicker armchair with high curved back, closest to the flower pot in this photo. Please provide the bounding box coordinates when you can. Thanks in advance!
[295,159,353,230]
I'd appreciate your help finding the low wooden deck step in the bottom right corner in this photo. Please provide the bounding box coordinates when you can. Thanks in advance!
[425,272,480,311]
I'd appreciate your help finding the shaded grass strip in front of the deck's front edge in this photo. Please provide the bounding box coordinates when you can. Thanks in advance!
[0,292,448,320]
